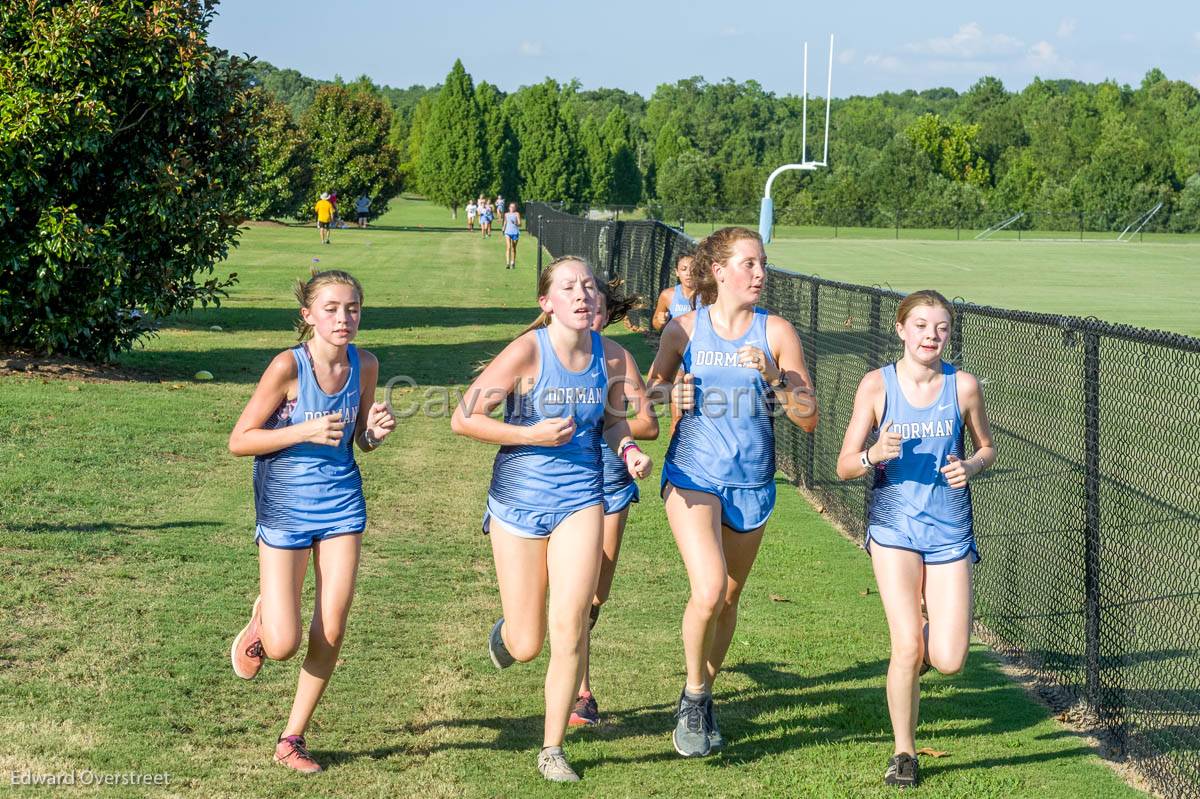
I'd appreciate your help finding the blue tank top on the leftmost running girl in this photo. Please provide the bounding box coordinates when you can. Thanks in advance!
[254,344,367,531]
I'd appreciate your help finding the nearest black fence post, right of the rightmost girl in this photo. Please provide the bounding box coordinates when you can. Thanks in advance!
[1084,332,1105,717]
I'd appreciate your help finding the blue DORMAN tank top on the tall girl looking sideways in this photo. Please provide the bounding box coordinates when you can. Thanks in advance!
[666,307,775,488]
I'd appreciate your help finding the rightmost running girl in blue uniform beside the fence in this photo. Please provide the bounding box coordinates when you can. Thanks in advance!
[838,290,996,786]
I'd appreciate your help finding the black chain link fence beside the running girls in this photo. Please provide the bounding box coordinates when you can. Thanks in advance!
[527,204,1200,797]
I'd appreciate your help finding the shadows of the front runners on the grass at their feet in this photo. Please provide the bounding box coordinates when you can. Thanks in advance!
[316,653,1092,774]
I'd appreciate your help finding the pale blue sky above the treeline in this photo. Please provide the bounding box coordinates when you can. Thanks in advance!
[210,0,1200,97]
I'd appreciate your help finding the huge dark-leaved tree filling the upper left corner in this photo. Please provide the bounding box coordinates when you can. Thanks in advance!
[0,0,256,359]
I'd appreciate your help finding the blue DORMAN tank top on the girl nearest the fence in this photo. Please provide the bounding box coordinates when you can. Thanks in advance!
[869,361,972,537]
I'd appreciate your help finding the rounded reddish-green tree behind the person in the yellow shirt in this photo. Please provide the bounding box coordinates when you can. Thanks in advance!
[301,85,400,215]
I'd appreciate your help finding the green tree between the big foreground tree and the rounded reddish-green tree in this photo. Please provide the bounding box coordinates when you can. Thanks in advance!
[246,90,313,220]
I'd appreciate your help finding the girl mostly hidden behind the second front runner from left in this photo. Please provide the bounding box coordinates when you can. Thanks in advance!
[568,283,659,726]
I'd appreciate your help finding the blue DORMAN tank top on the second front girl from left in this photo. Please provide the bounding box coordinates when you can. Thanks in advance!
[487,328,608,511]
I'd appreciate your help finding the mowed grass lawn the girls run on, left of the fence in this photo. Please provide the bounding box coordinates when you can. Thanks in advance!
[0,203,1138,799]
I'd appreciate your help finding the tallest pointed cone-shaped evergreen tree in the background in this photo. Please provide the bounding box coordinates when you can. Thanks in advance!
[416,60,490,218]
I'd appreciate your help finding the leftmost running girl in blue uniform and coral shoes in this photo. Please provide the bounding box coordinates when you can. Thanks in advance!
[229,271,396,773]
